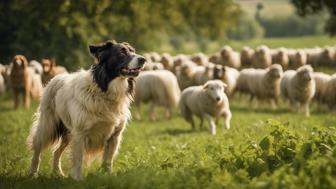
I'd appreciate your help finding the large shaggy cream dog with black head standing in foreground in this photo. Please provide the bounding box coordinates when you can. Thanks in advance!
[28,41,145,180]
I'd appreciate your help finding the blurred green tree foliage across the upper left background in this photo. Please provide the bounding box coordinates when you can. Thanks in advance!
[0,0,240,69]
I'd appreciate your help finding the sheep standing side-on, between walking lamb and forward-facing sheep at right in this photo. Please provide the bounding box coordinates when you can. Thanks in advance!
[238,64,283,109]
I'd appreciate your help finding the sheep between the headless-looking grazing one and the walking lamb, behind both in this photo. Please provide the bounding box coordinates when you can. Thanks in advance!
[176,60,197,90]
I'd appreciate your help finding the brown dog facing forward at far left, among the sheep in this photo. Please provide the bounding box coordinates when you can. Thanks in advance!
[9,55,42,109]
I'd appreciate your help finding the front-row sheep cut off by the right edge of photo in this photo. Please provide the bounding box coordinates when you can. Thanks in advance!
[322,74,336,110]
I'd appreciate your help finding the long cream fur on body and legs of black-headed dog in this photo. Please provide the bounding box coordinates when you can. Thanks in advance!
[28,70,131,180]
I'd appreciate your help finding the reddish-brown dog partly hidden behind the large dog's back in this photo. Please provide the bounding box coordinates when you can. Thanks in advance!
[41,58,67,86]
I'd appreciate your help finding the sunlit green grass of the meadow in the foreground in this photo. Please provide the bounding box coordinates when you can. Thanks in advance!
[0,89,336,189]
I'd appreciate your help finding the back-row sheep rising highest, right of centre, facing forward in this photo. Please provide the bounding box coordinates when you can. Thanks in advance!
[252,45,272,68]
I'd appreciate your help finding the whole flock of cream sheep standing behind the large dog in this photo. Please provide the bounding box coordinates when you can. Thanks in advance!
[0,45,336,134]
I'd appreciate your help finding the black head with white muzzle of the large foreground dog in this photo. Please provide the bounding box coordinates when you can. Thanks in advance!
[89,41,146,92]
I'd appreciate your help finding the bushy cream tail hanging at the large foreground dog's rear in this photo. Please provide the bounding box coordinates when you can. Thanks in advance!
[27,76,67,150]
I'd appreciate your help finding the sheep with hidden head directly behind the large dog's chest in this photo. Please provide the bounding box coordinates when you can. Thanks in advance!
[134,70,181,120]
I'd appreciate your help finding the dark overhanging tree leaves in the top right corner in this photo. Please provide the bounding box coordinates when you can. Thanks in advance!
[291,0,336,36]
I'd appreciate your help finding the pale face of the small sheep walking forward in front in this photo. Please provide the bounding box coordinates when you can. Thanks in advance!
[204,80,226,103]
